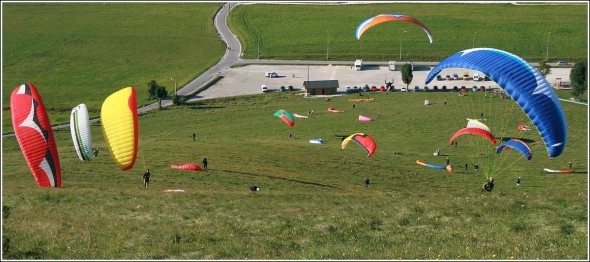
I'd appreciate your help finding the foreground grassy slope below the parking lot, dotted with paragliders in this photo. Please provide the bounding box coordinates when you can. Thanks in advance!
[2,92,588,260]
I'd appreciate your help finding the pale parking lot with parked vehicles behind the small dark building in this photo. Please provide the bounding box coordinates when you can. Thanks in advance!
[197,65,570,99]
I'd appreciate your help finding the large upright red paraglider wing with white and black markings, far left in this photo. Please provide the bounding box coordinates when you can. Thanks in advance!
[10,83,61,187]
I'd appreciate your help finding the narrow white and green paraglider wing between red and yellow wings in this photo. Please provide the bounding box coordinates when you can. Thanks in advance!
[70,104,92,160]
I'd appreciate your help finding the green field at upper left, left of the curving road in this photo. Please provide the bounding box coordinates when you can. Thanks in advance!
[2,3,225,133]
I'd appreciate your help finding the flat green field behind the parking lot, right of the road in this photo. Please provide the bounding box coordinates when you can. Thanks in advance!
[229,3,588,62]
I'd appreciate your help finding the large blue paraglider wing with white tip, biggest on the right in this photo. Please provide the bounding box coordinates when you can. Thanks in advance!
[426,48,567,157]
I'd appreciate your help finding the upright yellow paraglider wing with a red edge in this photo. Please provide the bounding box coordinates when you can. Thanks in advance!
[100,87,139,170]
